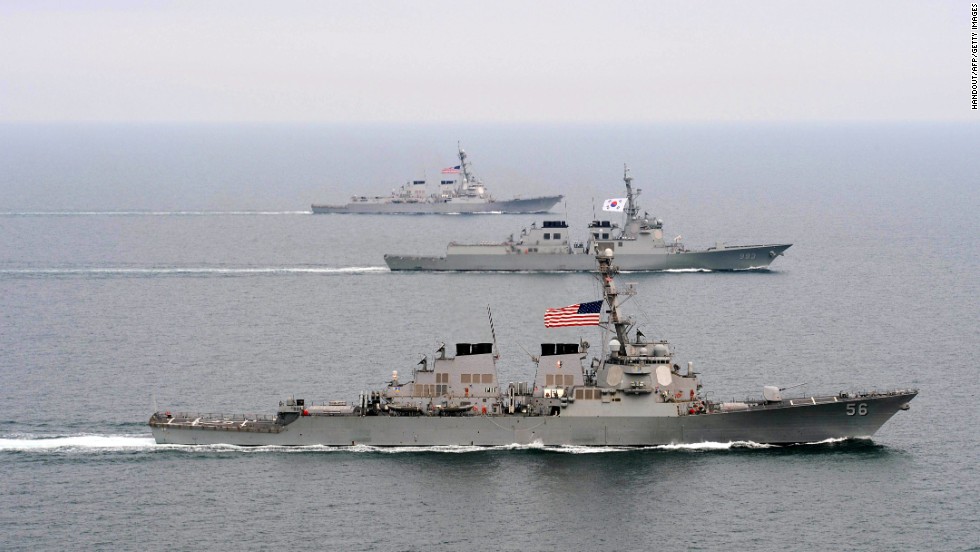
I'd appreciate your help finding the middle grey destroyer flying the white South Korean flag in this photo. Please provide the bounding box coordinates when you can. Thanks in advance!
[384,168,792,272]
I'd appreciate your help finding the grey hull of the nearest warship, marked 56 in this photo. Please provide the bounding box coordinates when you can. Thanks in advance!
[150,391,916,447]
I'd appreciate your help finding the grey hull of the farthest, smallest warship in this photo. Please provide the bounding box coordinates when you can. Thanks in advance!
[311,195,563,215]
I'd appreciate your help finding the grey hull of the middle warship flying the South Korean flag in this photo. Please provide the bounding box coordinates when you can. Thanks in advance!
[385,244,792,272]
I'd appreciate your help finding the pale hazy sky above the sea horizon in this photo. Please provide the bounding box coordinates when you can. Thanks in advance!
[0,0,964,122]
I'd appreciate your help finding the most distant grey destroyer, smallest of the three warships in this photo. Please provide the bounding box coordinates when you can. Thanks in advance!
[312,147,562,215]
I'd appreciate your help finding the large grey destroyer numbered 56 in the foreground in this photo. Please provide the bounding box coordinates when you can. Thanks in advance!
[149,251,918,447]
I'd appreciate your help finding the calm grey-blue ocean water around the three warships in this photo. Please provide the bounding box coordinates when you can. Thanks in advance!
[0,124,980,551]
